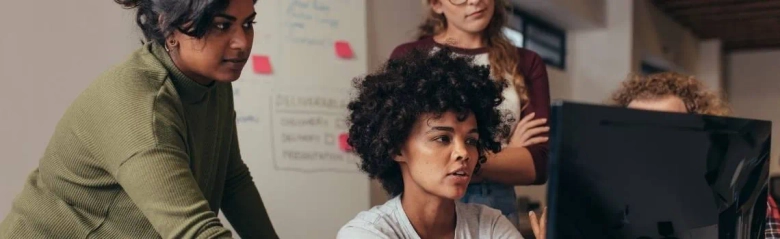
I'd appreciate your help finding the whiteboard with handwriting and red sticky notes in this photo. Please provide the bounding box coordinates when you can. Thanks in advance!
[224,0,369,238]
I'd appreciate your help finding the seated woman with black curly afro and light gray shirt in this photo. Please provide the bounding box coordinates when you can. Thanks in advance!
[337,49,522,239]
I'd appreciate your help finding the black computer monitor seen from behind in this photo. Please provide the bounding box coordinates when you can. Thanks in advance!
[547,102,771,239]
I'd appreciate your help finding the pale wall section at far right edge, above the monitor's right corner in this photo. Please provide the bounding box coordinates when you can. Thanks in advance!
[727,50,780,175]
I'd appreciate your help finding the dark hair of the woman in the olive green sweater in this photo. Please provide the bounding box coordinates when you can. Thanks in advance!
[114,0,257,45]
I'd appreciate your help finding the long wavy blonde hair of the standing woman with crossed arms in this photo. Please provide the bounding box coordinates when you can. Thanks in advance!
[417,0,529,106]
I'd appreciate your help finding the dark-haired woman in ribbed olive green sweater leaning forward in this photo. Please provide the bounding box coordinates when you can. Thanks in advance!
[0,0,277,238]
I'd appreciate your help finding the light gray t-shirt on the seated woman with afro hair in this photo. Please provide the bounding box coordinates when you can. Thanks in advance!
[336,196,523,239]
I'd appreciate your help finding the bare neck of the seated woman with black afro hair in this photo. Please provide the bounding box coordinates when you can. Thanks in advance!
[401,189,457,238]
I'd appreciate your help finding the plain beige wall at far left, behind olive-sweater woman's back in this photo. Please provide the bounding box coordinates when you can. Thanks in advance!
[0,0,140,218]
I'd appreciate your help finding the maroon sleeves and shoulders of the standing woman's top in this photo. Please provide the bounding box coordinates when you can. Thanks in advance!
[390,37,550,185]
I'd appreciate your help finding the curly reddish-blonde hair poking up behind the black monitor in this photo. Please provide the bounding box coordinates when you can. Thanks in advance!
[611,72,731,116]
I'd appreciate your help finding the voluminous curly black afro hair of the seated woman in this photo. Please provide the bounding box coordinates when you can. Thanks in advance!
[347,48,509,196]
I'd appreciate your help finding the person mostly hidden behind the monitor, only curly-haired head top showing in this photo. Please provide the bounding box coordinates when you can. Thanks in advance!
[611,72,730,116]
